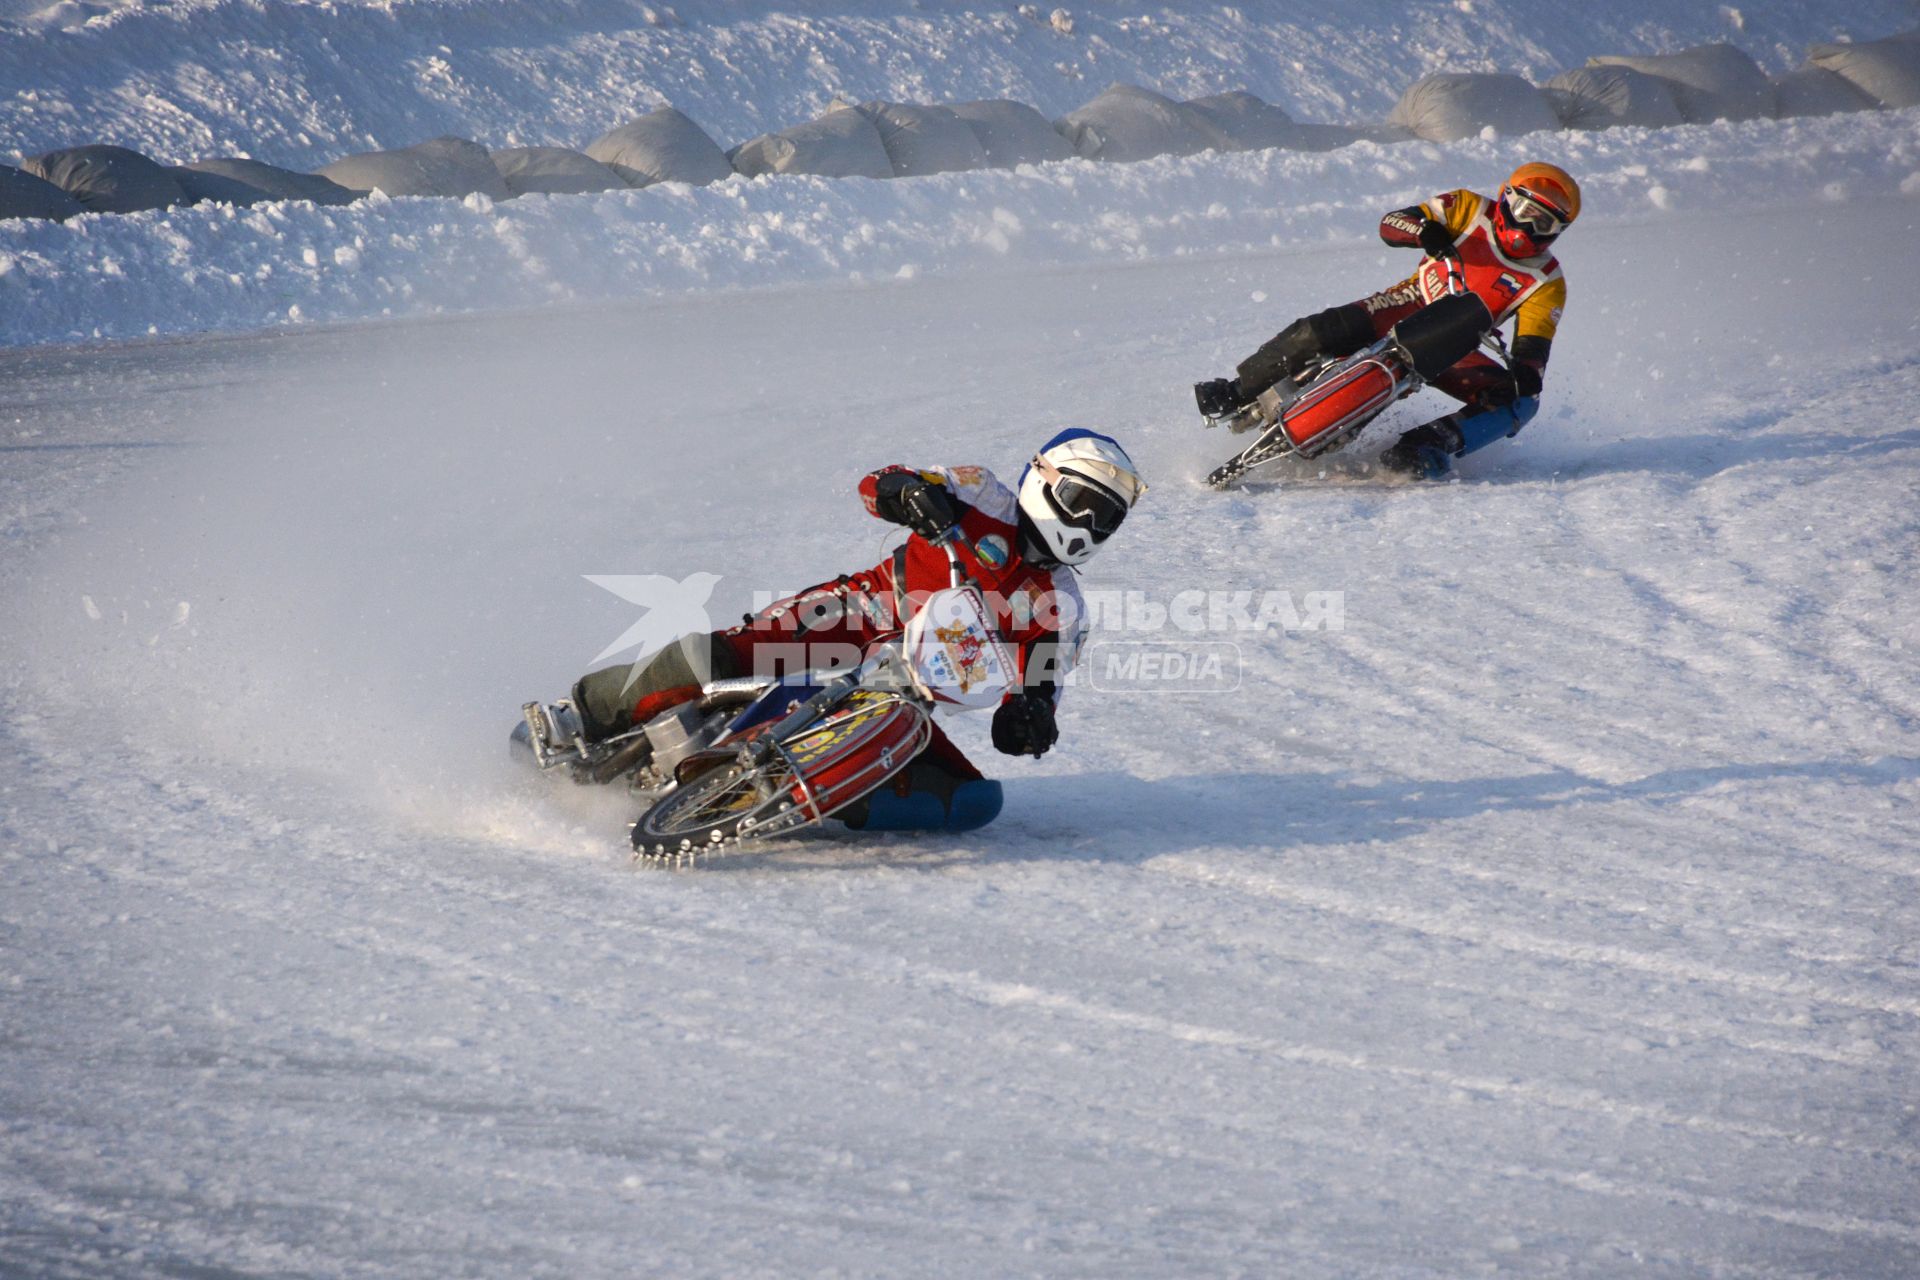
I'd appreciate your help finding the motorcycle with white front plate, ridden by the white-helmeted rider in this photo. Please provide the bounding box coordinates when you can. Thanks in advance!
[513,530,1020,867]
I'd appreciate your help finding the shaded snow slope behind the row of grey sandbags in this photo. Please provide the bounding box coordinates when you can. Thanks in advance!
[0,0,1912,169]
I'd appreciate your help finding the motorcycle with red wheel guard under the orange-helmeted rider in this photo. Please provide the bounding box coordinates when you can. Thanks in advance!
[1206,257,1511,489]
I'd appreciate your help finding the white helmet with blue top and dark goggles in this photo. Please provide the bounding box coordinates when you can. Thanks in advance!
[1020,428,1146,564]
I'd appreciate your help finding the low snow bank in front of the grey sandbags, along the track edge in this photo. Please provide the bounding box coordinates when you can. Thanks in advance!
[0,111,1920,345]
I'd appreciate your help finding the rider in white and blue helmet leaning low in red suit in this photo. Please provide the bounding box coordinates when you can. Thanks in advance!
[530,428,1146,829]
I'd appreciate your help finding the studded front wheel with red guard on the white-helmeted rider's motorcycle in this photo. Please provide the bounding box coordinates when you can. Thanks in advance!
[634,689,933,867]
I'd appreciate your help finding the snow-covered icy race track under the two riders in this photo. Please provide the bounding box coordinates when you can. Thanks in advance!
[0,185,1920,1278]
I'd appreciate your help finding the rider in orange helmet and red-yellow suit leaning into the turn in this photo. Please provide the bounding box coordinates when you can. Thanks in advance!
[1194,163,1580,480]
